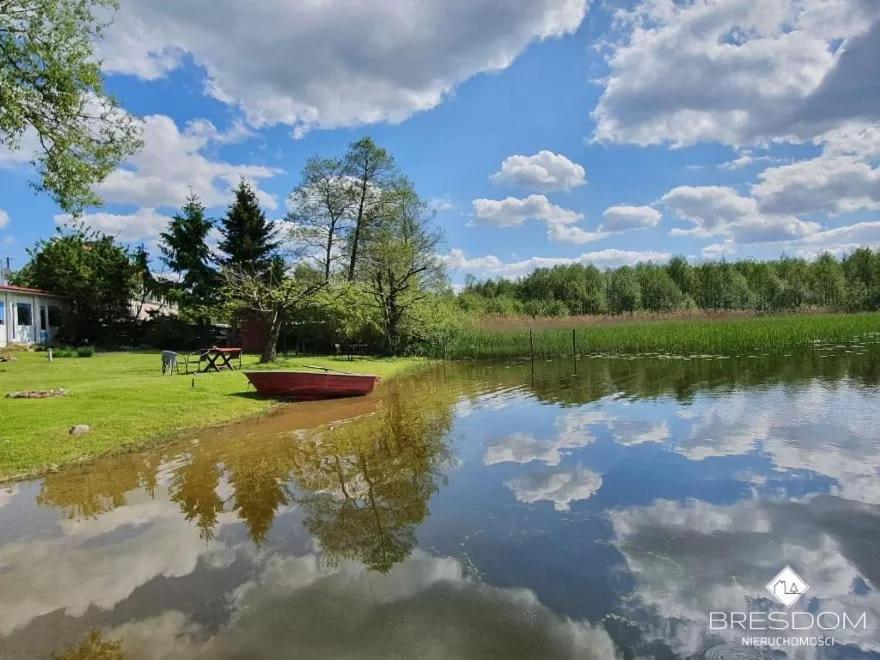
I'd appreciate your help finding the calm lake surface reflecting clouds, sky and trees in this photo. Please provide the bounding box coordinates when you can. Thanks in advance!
[0,346,880,659]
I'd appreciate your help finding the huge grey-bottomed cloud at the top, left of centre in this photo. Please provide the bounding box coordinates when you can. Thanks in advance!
[101,0,587,135]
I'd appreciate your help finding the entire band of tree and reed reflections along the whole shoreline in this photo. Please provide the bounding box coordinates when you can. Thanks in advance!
[31,348,880,556]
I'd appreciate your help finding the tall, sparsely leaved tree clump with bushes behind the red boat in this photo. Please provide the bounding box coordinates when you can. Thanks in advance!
[287,137,450,354]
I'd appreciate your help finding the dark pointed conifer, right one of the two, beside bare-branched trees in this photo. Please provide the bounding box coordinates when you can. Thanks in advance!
[220,179,281,272]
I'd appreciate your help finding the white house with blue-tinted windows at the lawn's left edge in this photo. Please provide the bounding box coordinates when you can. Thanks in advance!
[0,284,65,347]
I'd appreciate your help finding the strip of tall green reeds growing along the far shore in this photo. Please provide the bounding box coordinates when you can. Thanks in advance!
[432,312,880,359]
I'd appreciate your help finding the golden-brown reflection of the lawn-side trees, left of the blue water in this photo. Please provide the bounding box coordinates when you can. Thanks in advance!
[37,366,458,572]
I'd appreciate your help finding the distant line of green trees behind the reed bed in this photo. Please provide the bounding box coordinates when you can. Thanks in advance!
[458,248,880,316]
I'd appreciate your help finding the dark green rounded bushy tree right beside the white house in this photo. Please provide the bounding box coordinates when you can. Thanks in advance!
[15,228,138,343]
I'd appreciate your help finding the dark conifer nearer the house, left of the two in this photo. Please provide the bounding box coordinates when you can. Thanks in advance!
[159,194,219,316]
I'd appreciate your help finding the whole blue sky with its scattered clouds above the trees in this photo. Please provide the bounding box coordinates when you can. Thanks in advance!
[0,0,880,282]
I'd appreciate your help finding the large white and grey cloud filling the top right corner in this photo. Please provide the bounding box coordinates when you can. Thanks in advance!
[593,0,880,146]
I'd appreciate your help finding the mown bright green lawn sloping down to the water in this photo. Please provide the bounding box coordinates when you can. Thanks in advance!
[0,351,420,480]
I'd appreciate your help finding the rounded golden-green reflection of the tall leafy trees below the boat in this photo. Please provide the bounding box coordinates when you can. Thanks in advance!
[294,386,452,573]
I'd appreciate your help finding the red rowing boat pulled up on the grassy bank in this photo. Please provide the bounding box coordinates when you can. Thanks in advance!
[245,371,379,399]
